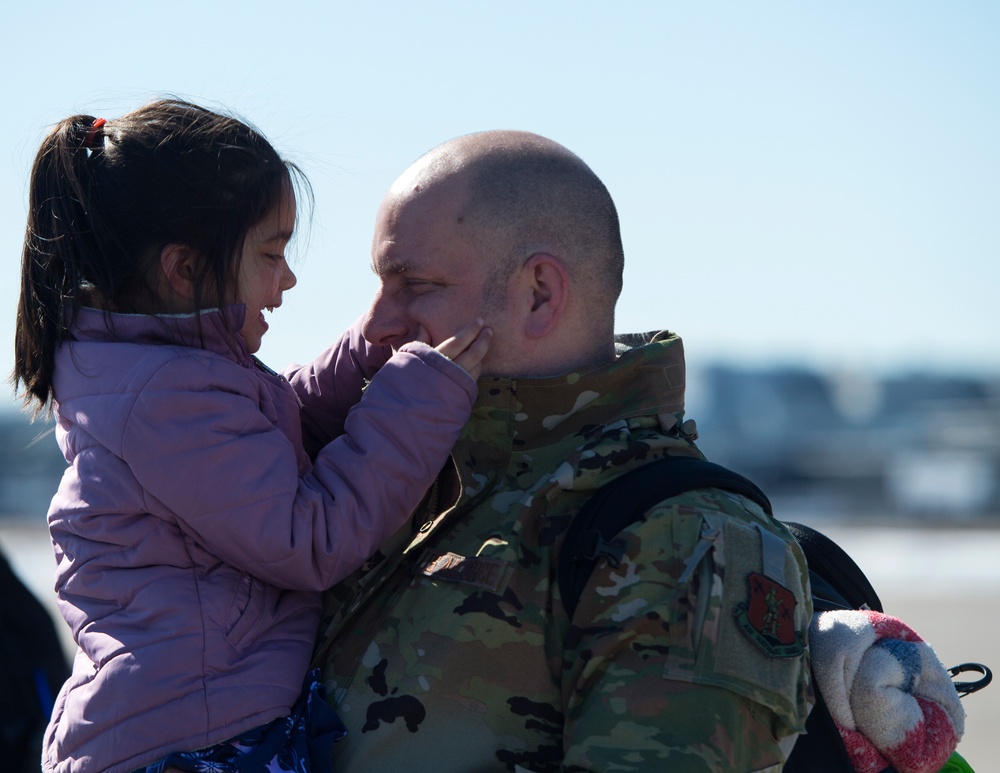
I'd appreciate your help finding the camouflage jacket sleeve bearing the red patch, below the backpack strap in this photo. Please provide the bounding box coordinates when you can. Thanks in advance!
[562,490,811,771]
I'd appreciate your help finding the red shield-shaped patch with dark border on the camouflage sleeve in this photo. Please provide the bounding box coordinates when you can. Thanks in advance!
[733,572,805,658]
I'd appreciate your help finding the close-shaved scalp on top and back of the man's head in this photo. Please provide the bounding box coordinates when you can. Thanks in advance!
[392,131,624,327]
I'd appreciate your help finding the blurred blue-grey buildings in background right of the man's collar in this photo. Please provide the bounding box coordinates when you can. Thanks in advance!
[688,366,1000,518]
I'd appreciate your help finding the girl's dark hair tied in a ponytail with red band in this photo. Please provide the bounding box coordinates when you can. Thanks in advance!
[11,99,308,410]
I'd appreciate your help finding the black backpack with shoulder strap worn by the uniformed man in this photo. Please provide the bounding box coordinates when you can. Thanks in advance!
[556,456,990,773]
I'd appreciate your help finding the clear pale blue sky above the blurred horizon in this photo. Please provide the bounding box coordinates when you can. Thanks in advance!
[0,0,1000,404]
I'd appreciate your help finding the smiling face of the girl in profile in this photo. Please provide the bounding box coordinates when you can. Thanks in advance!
[235,187,296,354]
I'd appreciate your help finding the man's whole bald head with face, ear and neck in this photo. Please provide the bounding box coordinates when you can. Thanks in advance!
[364,131,624,376]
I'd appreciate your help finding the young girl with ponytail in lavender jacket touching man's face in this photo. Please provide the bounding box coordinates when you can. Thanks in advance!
[13,100,489,773]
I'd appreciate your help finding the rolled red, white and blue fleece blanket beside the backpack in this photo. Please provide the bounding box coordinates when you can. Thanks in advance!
[809,610,965,773]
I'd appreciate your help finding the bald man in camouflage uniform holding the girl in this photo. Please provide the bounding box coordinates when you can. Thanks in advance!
[318,132,811,773]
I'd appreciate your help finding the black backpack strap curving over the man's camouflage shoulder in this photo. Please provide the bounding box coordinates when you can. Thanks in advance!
[556,456,771,617]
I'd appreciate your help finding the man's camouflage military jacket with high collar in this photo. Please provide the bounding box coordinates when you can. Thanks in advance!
[318,333,811,773]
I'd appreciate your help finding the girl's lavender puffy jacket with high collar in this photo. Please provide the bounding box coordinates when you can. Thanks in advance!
[43,306,475,773]
